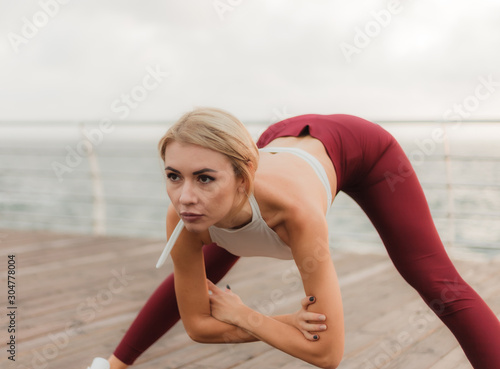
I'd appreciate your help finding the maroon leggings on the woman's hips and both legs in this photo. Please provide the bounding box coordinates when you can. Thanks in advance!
[114,114,500,369]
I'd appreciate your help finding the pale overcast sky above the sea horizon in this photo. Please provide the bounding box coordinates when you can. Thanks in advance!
[0,0,500,122]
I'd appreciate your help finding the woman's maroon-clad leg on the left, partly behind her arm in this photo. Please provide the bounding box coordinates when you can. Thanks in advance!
[110,243,239,369]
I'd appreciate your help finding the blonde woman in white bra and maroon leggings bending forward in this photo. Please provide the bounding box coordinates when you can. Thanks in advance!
[92,109,500,369]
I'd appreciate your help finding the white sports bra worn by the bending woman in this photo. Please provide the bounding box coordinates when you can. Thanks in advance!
[156,147,333,268]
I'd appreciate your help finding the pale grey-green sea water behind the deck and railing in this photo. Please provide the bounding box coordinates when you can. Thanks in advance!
[0,122,500,254]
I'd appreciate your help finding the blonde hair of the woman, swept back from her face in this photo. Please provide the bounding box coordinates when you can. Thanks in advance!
[158,108,259,195]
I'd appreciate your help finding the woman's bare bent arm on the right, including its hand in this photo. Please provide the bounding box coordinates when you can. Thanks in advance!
[211,208,344,369]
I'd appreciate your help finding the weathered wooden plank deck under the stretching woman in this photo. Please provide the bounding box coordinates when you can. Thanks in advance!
[0,230,500,369]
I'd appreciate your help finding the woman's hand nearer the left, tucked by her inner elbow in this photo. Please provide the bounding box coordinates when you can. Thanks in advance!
[207,279,245,325]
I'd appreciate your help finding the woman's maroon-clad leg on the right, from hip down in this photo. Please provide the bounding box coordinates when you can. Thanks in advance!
[345,140,500,369]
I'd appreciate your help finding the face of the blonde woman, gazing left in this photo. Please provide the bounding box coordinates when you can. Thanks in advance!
[165,141,244,232]
